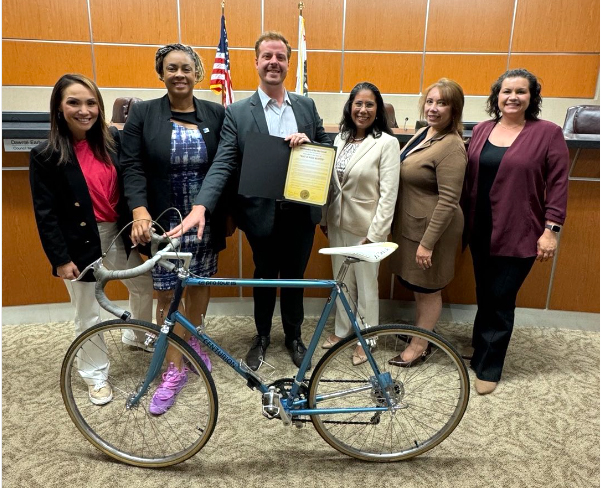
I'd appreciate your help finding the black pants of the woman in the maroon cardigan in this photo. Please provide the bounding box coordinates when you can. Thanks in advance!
[470,243,535,382]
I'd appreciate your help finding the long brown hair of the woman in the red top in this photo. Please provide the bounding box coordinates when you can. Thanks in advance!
[48,74,115,164]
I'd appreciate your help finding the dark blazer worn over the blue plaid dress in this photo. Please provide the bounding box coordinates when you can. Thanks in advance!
[121,95,226,251]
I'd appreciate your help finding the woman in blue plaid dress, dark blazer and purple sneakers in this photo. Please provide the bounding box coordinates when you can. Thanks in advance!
[121,44,225,415]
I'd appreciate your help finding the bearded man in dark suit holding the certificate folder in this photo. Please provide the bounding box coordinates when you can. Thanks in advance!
[169,32,332,370]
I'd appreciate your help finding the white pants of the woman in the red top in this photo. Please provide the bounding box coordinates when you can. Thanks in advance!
[64,222,153,385]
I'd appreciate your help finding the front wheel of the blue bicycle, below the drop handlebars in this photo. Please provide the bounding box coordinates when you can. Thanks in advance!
[60,320,217,467]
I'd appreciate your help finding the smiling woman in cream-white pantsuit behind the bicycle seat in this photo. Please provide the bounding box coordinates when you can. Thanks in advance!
[321,82,400,365]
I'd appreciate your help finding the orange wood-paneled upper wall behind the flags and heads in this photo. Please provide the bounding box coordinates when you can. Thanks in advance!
[2,0,599,98]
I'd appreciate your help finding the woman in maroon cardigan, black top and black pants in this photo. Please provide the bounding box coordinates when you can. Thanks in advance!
[462,69,569,395]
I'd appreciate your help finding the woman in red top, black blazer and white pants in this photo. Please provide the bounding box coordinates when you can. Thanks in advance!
[29,74,152,405]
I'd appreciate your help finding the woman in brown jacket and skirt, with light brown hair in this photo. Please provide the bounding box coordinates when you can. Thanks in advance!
[389,78,467,367]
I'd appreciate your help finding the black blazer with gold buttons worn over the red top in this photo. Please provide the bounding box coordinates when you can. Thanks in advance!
[29,128,131,281]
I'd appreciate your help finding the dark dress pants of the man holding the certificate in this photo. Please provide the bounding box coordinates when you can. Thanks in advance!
[246,202,315,341]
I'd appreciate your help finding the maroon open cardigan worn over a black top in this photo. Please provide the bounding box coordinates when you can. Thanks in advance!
[461,120,570,258]
